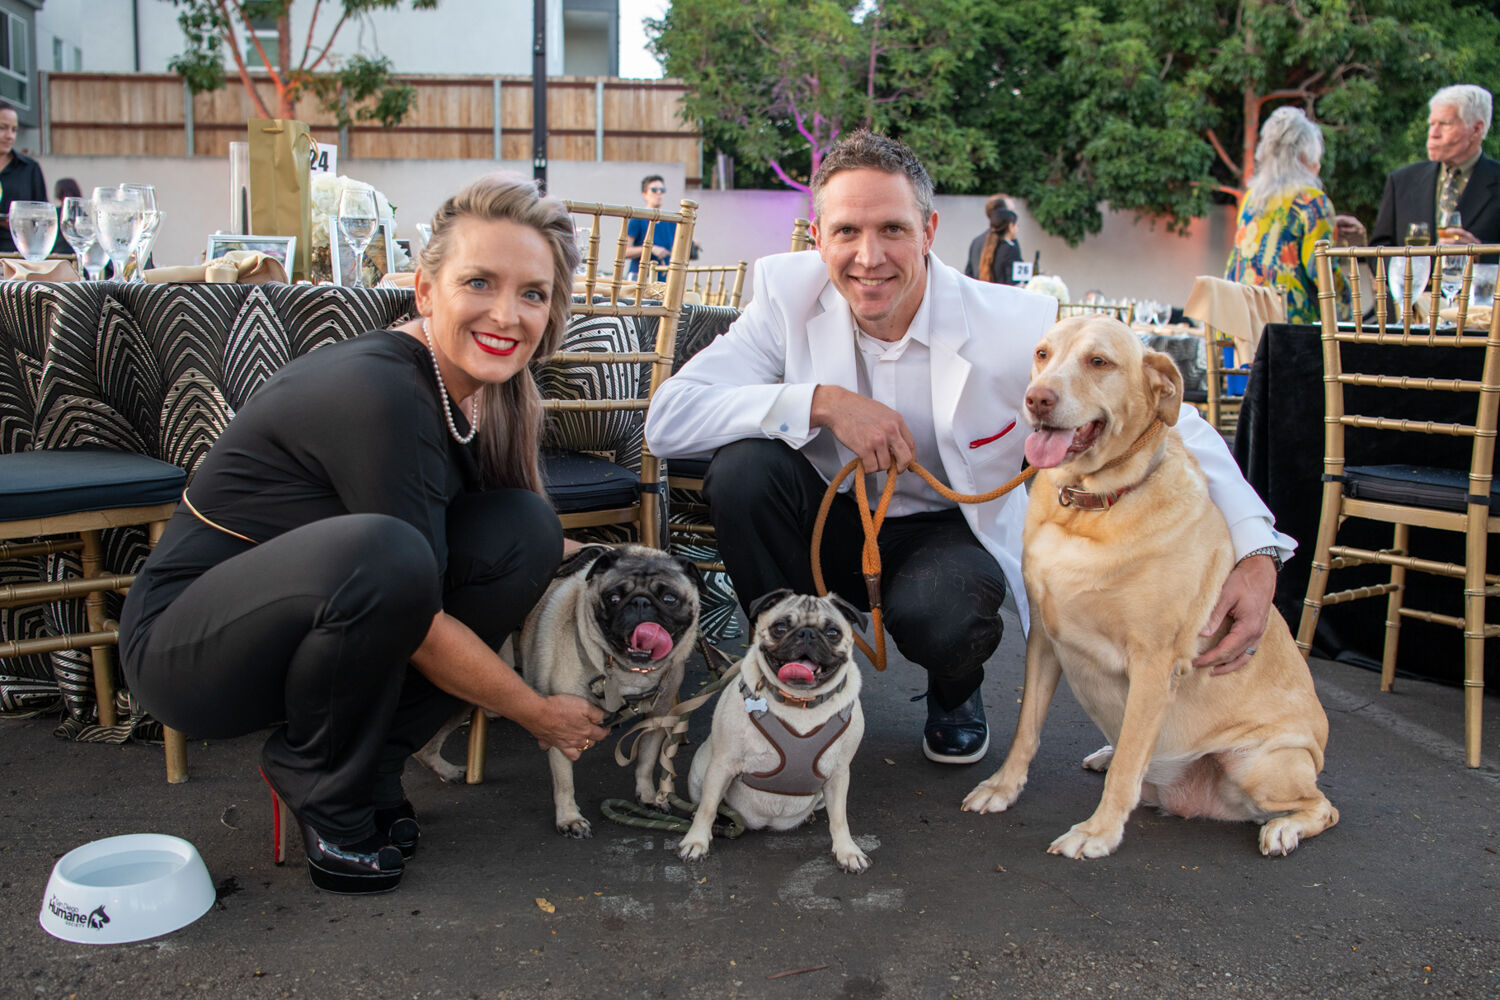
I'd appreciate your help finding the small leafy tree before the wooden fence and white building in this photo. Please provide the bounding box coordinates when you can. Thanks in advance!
[168,0,438,127]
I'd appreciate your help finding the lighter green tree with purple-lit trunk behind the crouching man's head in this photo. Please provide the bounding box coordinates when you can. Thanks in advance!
[647,0,996,206]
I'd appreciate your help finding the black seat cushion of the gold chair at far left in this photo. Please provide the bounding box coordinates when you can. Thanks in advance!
[0,448,188,520]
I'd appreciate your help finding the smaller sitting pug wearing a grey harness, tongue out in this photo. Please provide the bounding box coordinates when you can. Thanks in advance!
[678,589,870,873]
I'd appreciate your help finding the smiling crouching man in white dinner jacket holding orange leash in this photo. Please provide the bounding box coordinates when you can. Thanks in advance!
[647,130,1296,763]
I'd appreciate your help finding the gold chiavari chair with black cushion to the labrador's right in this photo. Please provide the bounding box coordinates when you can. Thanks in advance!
[1298,241,1500,768]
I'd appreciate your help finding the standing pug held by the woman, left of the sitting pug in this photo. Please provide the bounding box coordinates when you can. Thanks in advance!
[521,544,701,838]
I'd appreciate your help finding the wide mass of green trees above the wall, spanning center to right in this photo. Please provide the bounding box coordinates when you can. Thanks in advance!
[654,0,1500,243]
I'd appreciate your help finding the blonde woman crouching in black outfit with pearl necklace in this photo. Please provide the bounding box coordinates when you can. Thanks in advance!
[120,174,608,892]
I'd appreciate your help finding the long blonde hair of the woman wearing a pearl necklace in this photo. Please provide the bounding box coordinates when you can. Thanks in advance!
[419,172,579,496]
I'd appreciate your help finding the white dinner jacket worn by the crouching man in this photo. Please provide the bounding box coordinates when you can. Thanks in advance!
[645,250,1296,624]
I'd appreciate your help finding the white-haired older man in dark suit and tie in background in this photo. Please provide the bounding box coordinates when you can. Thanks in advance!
[1370,84,1500,246]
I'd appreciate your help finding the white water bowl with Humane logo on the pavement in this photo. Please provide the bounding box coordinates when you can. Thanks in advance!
[41,834,215,945]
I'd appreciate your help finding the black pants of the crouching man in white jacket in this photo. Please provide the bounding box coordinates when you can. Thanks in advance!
[704,439,1005,709]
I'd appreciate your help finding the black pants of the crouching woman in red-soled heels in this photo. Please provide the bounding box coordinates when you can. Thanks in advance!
[128,490,563,843]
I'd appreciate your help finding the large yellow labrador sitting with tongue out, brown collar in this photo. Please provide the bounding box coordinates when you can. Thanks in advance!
[963,316,1338,858]
